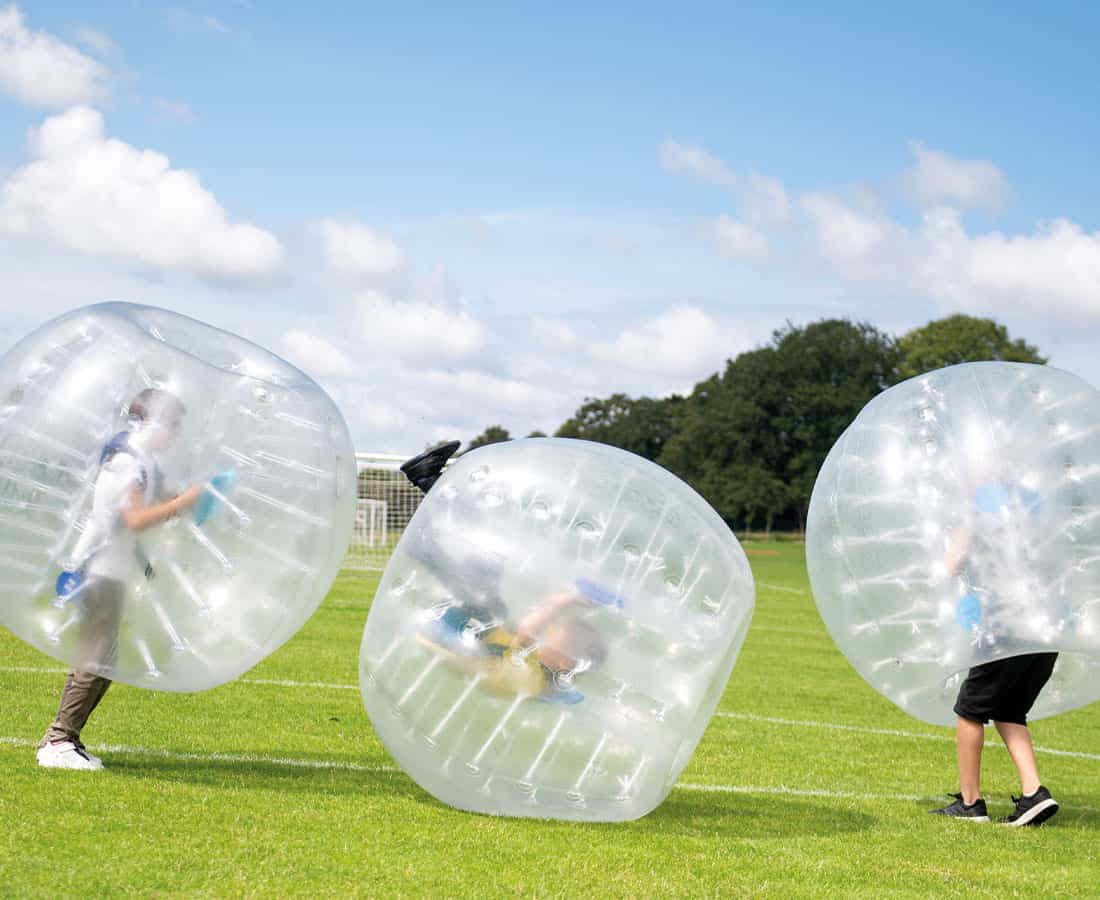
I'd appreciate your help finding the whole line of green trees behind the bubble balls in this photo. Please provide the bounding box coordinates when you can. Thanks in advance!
[466,315,1046,531]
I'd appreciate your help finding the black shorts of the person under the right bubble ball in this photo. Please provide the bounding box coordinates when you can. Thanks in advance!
[955,654,1058,725]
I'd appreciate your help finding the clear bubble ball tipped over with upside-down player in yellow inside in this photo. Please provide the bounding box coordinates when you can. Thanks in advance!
[360,439,754,821]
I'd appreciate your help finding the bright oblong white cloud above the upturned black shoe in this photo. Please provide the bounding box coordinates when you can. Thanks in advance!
[358,290,486,361]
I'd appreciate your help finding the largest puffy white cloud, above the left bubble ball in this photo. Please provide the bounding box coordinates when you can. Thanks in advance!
[0,107,283,284]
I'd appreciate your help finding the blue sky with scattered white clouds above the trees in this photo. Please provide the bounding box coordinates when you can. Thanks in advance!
[0,0,1100,452]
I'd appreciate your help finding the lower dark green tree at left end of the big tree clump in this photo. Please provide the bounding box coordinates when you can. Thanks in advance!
[554,394,683,460]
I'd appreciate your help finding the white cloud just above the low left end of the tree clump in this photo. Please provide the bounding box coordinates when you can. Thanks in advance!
[589,304,745,375]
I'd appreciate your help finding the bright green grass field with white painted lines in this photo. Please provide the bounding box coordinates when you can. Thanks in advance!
[0,542,1100,897]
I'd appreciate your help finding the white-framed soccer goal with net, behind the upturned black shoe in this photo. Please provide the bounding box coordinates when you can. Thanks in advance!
[344,453,422,572]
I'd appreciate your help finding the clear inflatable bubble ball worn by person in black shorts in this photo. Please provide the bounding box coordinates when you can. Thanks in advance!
[806,362,1100,725]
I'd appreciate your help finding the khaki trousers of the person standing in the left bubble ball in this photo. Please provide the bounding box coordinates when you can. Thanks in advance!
[40,578,125,747]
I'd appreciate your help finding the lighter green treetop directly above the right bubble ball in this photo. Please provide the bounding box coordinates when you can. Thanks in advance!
[898,315,1046,378]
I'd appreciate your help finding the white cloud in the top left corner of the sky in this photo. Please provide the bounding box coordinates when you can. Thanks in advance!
[0,4,110,107]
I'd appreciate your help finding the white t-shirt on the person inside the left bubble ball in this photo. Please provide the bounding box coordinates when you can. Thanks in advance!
[74,437,160,581]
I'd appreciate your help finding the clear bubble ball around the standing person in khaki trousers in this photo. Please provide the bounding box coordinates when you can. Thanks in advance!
[0,303,355,691]
